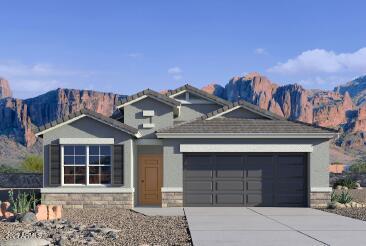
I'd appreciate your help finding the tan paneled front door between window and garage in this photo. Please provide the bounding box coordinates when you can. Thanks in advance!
[139,155,163,205]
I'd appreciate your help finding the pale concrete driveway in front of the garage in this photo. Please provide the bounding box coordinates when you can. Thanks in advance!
[184,208,366,246]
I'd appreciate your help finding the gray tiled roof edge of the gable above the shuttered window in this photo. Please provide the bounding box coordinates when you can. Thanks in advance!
[33,109,138,135]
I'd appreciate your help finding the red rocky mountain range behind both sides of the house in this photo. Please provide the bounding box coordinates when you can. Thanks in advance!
[0,73,366,165]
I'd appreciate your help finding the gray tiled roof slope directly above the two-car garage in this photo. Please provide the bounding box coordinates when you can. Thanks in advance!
[158,118,334,134]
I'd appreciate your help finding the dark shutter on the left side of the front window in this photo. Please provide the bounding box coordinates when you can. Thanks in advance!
[49,144,61,186]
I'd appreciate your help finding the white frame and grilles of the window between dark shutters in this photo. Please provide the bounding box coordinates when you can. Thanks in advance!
[61,144,113,187]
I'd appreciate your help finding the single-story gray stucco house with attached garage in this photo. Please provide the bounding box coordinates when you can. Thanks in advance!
[36,85,336,208]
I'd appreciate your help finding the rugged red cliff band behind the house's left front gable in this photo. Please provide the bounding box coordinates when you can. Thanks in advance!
[0,89,124,150]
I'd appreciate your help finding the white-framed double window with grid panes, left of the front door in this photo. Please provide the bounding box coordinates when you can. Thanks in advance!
[63,145,112,185]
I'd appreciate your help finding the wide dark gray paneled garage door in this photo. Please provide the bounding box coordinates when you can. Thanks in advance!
[183,153,308,207]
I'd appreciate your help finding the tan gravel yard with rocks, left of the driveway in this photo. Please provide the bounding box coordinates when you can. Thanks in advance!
[0,208,192,245]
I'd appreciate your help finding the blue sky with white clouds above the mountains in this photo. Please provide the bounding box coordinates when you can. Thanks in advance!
[0,0,366,98]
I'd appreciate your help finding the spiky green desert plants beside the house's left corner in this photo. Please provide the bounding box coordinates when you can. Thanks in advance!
[8,190,40,213]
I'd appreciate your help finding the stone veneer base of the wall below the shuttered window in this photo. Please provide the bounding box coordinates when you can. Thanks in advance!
[42,193,134,209]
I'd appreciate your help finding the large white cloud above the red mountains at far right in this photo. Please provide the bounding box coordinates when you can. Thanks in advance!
[268,47,366,75]
